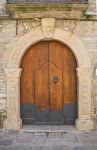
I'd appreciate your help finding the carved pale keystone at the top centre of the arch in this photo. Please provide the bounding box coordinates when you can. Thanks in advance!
[41,18,56,38]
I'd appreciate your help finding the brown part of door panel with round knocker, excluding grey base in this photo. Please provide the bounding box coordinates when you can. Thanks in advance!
[49,63,62,111]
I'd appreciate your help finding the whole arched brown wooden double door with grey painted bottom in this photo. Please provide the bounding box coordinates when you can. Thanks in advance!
[20,41,77,124]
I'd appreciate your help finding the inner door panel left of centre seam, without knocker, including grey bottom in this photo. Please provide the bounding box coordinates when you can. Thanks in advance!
[35,63,49,122]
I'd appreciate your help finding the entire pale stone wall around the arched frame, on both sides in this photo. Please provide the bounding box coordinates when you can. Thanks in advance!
[0,0,97,129]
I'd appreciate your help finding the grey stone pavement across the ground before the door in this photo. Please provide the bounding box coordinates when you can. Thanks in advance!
[0,127,97,150]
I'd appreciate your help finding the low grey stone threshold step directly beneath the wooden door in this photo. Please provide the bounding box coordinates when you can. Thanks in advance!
[21,125,77,134]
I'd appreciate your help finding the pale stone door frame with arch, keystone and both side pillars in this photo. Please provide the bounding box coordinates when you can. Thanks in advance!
[3,19,94,130]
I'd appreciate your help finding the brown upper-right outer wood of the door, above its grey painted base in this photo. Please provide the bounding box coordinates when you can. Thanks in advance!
[49,41,77,103]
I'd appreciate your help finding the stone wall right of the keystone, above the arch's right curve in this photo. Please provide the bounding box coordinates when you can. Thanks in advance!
[56,20,97,65]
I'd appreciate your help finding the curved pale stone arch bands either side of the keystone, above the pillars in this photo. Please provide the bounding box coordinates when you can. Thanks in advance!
[7,28,91,68]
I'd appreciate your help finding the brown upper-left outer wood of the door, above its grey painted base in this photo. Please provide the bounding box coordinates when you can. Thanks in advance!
[20,42,48,104]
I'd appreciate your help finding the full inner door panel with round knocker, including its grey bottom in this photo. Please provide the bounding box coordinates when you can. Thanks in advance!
[49,63,63,122]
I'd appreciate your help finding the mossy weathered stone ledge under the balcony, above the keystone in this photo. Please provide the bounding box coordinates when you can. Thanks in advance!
[5,3,88,19]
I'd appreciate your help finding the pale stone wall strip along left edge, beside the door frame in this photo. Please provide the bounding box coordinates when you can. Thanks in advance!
[0,20,16,109]
